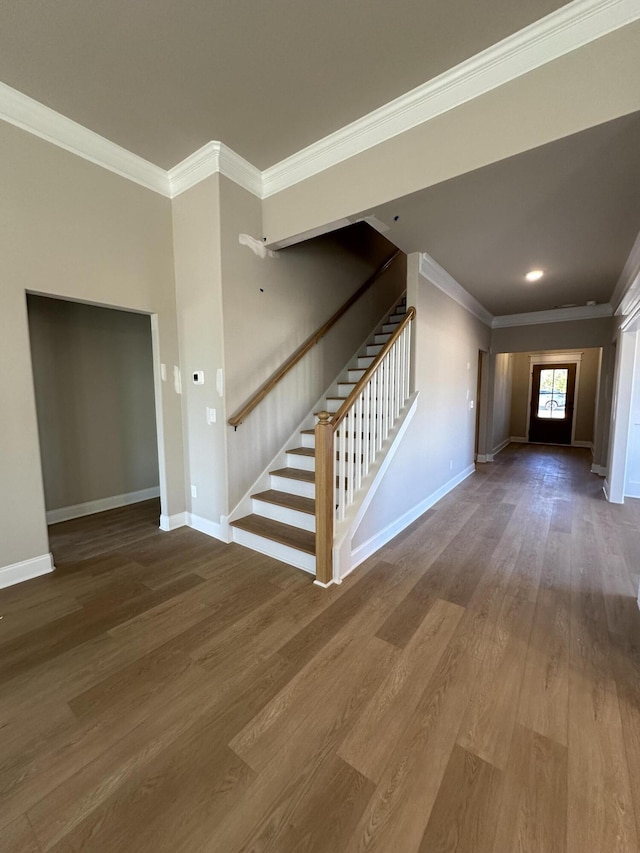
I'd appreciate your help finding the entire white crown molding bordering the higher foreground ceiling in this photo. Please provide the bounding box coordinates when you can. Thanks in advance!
[0,0,640,198]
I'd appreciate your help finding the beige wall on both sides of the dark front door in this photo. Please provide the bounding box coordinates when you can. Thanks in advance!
[511,348,600,443]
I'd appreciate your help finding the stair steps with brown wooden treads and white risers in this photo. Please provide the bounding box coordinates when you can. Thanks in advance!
[231,297,406,574]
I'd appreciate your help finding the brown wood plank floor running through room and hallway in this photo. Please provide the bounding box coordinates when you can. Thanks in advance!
[0,445,640,853]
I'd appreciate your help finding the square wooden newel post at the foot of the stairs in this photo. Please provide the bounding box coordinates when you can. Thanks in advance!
[315,412,335,585]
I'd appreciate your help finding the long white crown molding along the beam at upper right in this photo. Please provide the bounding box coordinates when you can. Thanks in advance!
[262,0,640,198]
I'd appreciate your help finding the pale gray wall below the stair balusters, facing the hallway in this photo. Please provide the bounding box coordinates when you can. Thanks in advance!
[352,255,491,547]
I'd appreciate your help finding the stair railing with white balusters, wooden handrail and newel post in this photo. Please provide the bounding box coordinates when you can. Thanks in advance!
[315,308,416,585]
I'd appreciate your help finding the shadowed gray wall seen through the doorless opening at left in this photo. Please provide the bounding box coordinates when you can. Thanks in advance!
[28,296,158,511]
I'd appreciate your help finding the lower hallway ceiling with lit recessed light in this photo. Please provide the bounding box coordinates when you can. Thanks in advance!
[364,113,640,316]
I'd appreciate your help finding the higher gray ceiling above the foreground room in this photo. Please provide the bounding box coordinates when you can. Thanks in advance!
[0,0,565,169]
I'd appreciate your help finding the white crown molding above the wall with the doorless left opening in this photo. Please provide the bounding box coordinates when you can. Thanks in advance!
[0,83,169,196]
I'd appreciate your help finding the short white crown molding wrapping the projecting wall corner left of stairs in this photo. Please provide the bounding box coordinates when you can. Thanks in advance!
[167,142,262,198]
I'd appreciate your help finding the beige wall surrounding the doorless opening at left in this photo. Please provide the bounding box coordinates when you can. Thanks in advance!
[0,123,184,567]
